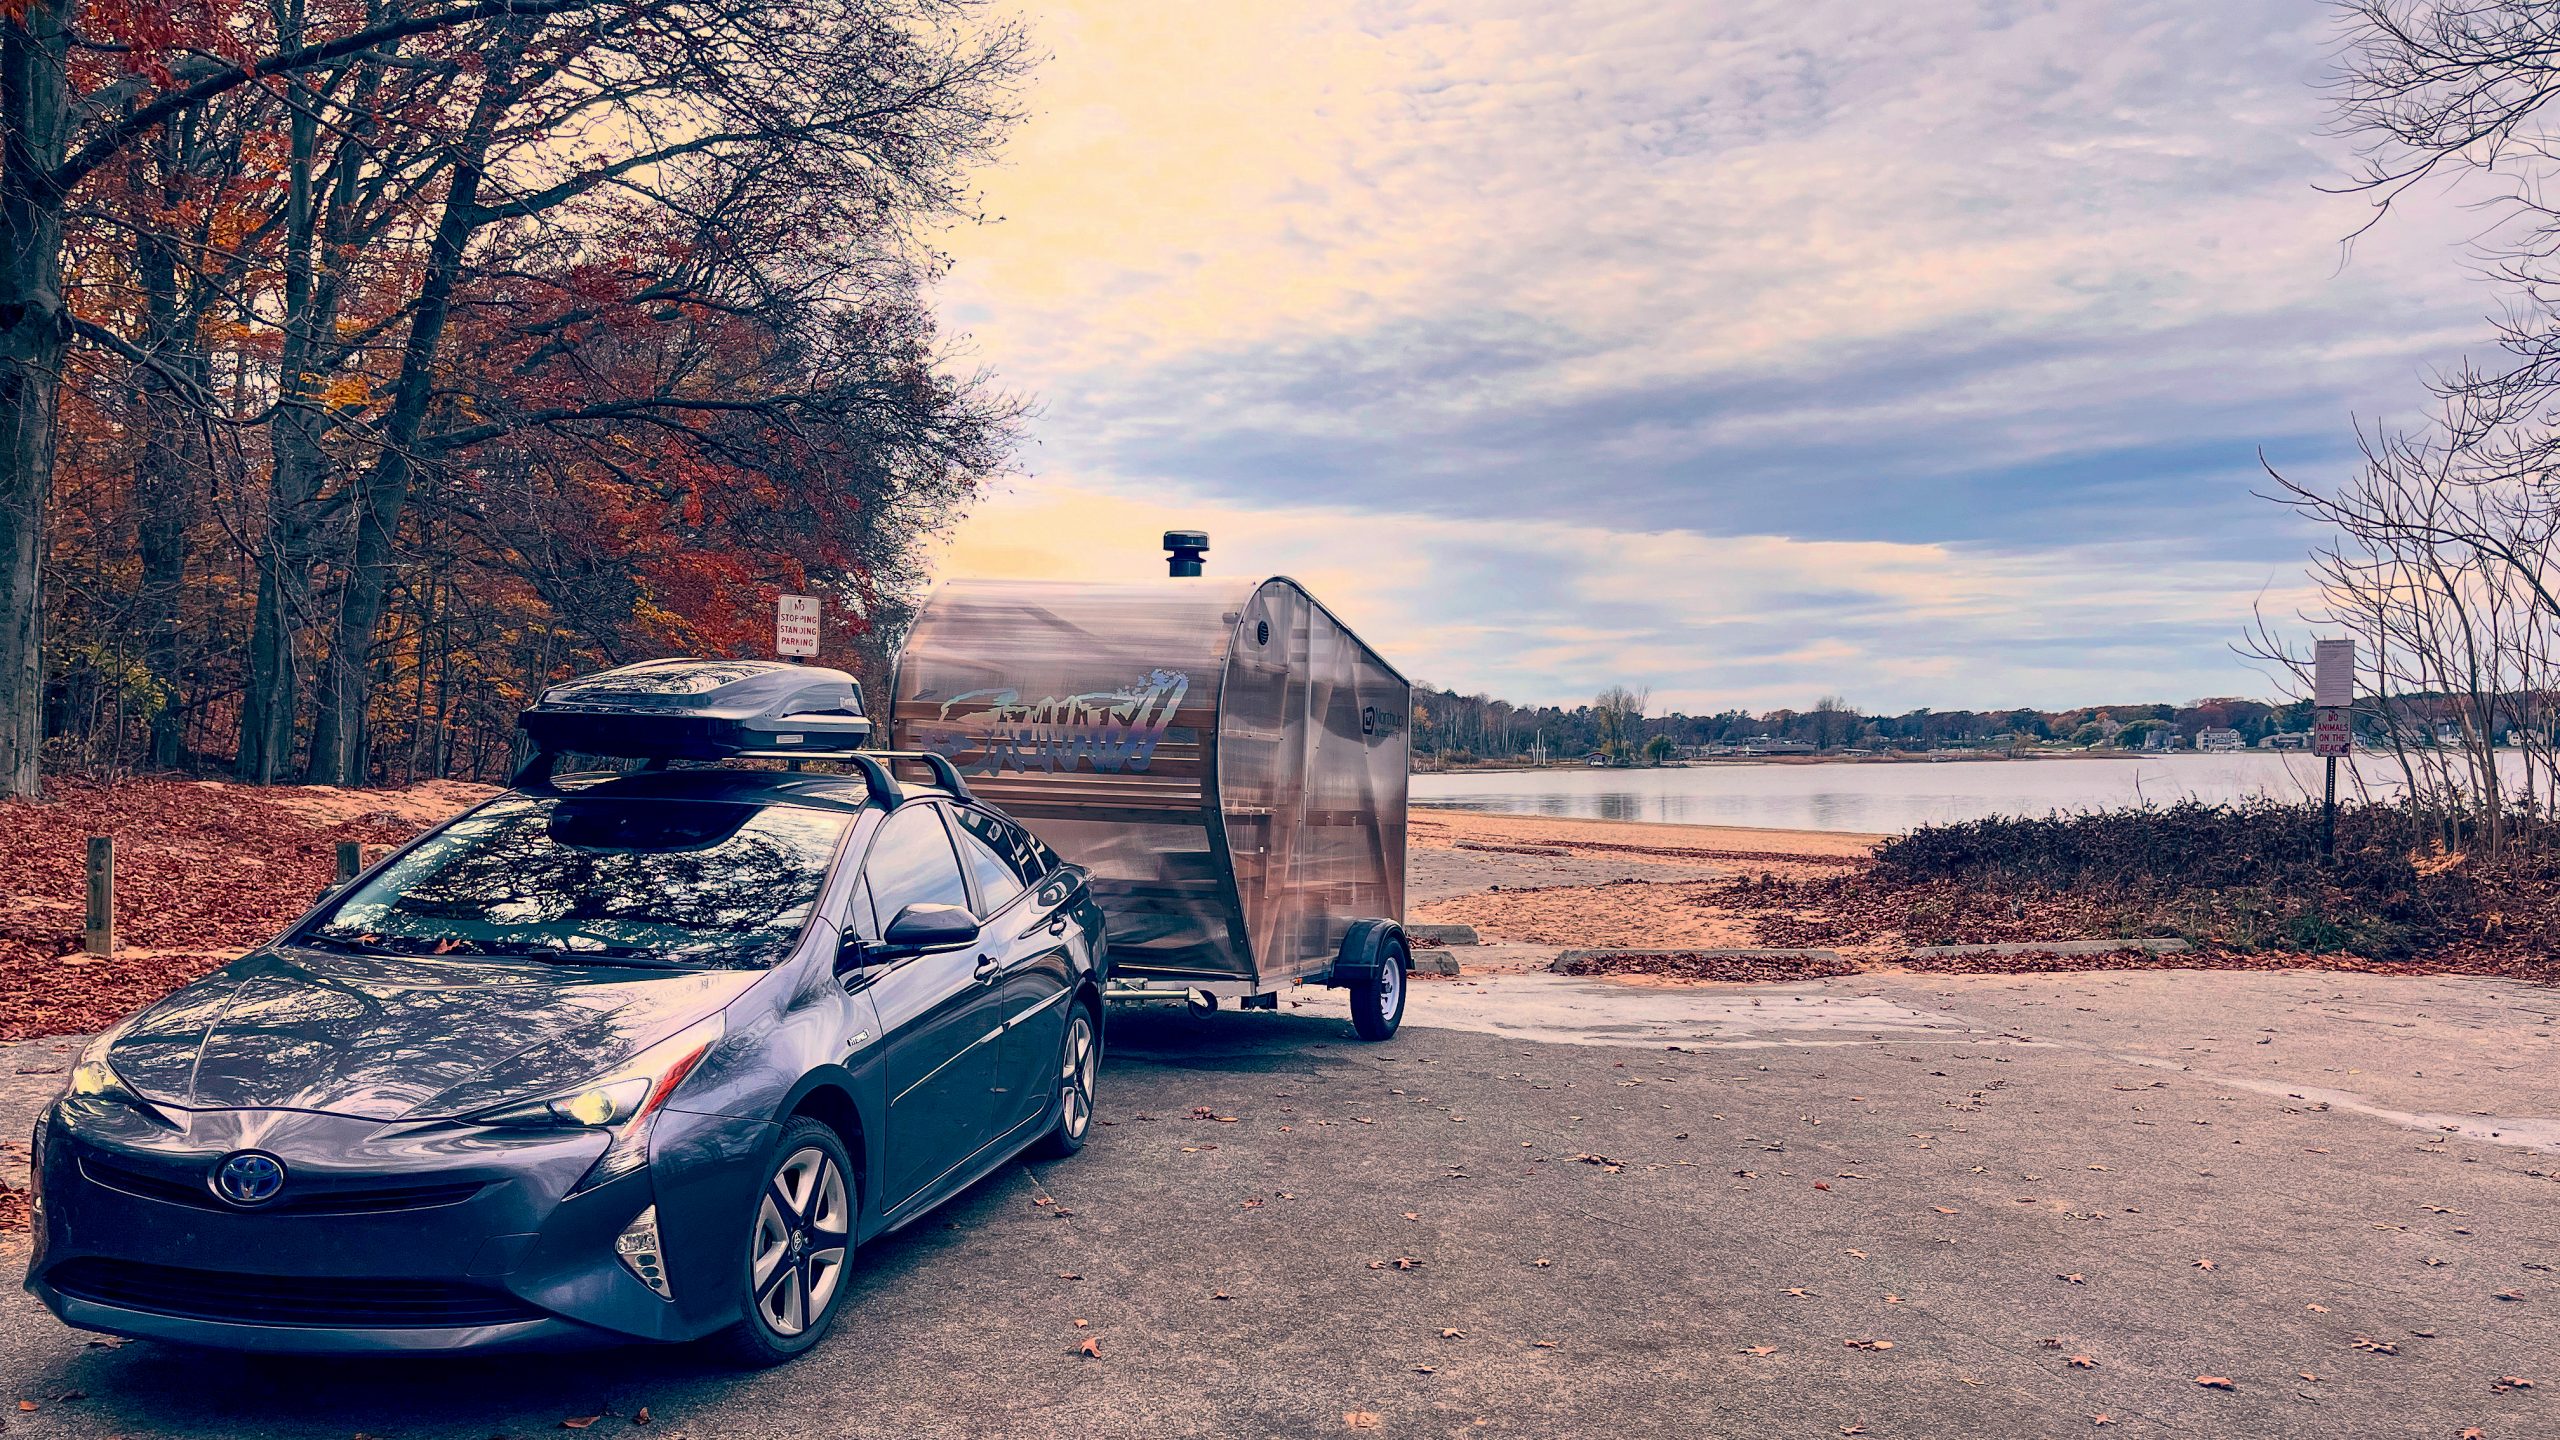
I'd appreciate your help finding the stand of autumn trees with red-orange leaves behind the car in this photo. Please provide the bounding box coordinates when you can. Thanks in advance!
[0,0,1027,794]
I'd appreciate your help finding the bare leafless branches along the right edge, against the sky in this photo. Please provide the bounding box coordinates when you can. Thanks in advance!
[2245,0,2560,848]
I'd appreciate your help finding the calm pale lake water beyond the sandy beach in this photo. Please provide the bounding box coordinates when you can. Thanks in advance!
[1413,751,2511,833]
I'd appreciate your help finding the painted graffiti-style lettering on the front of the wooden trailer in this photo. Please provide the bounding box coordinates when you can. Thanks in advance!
[916,669,1190,774]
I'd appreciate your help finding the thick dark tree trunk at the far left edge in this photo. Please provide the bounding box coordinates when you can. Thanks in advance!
[0,0,72,799]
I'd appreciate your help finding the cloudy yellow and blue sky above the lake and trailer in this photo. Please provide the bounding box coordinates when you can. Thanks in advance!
[940,0,2493,712]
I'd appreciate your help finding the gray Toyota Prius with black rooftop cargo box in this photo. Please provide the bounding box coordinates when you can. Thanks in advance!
[28,661,1106,1363]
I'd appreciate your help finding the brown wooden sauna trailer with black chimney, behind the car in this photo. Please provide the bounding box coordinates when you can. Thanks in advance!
[888,545,1413,1040]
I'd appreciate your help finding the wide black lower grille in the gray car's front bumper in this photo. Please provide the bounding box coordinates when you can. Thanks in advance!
[44,1256,543,1330]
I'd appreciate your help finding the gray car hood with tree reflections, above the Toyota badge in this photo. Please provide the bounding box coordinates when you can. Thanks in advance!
[108,948,763,1120]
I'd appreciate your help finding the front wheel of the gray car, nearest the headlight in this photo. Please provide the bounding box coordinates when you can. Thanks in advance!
[722,1115,863,1368]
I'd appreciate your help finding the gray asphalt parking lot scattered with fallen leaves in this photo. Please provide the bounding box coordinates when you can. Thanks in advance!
[0,953,2560,1440]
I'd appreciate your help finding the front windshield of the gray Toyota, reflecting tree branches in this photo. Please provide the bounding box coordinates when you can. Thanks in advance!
[300,797,852,969]
